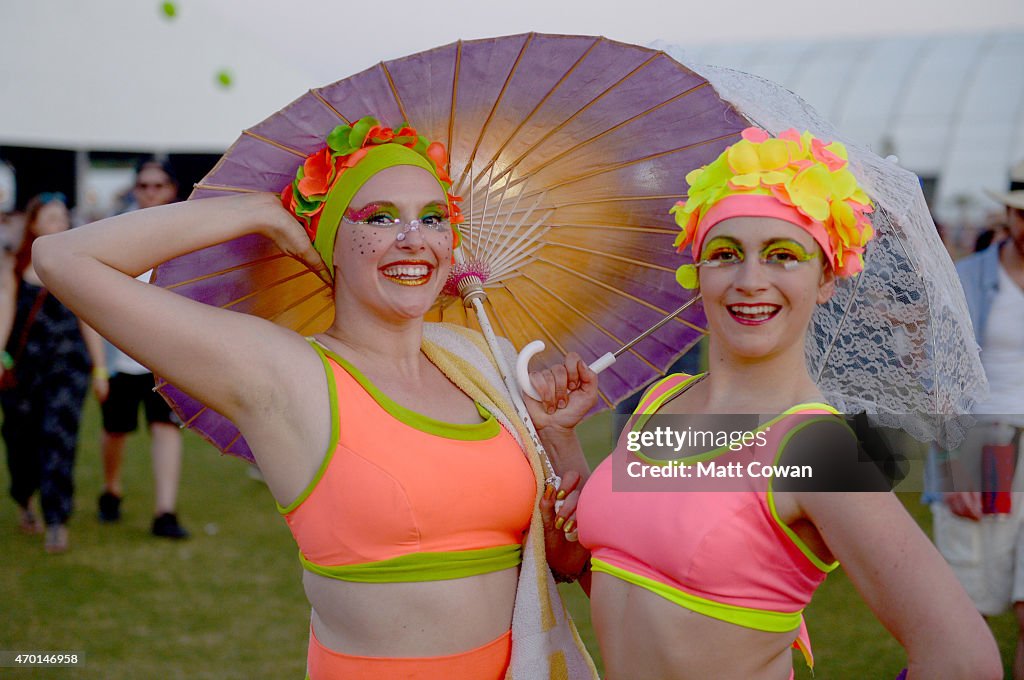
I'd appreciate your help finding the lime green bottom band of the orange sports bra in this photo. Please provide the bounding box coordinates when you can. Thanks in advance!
[299,544,522,583]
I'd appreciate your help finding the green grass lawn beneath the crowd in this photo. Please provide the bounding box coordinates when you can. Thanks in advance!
[0,399,1016,680]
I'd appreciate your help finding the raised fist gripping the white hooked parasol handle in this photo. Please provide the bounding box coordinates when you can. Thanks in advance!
[524,352,597,432]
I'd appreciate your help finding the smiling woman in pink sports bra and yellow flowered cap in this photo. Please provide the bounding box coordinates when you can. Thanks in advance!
[535,128,1001,680]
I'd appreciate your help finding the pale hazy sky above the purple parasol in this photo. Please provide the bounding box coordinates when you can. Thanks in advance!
[211,0,1024,83]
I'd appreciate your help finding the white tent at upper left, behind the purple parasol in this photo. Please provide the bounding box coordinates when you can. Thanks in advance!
[0,0,323,153]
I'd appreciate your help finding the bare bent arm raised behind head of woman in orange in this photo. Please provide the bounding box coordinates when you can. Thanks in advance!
[33,194,327,426]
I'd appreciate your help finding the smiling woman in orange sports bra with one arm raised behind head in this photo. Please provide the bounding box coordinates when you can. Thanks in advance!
[35,118,596,680]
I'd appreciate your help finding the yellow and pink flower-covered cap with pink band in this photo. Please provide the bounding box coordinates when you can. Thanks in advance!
[671,127,874,288]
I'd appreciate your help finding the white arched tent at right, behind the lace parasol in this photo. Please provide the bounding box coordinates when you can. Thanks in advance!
[652,32,1024,224]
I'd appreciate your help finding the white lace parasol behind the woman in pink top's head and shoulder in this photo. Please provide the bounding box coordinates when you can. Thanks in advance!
[686,63,988,445]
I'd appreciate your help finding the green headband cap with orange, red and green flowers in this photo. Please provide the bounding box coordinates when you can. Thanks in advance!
[281,116,463,266]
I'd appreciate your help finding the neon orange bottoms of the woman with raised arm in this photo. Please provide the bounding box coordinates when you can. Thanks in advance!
[306,626,512,680]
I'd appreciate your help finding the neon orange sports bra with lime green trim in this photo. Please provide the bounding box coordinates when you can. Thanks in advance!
[278,342,537,583]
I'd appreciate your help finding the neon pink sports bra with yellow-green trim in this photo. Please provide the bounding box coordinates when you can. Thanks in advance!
[577,375,838,664]
